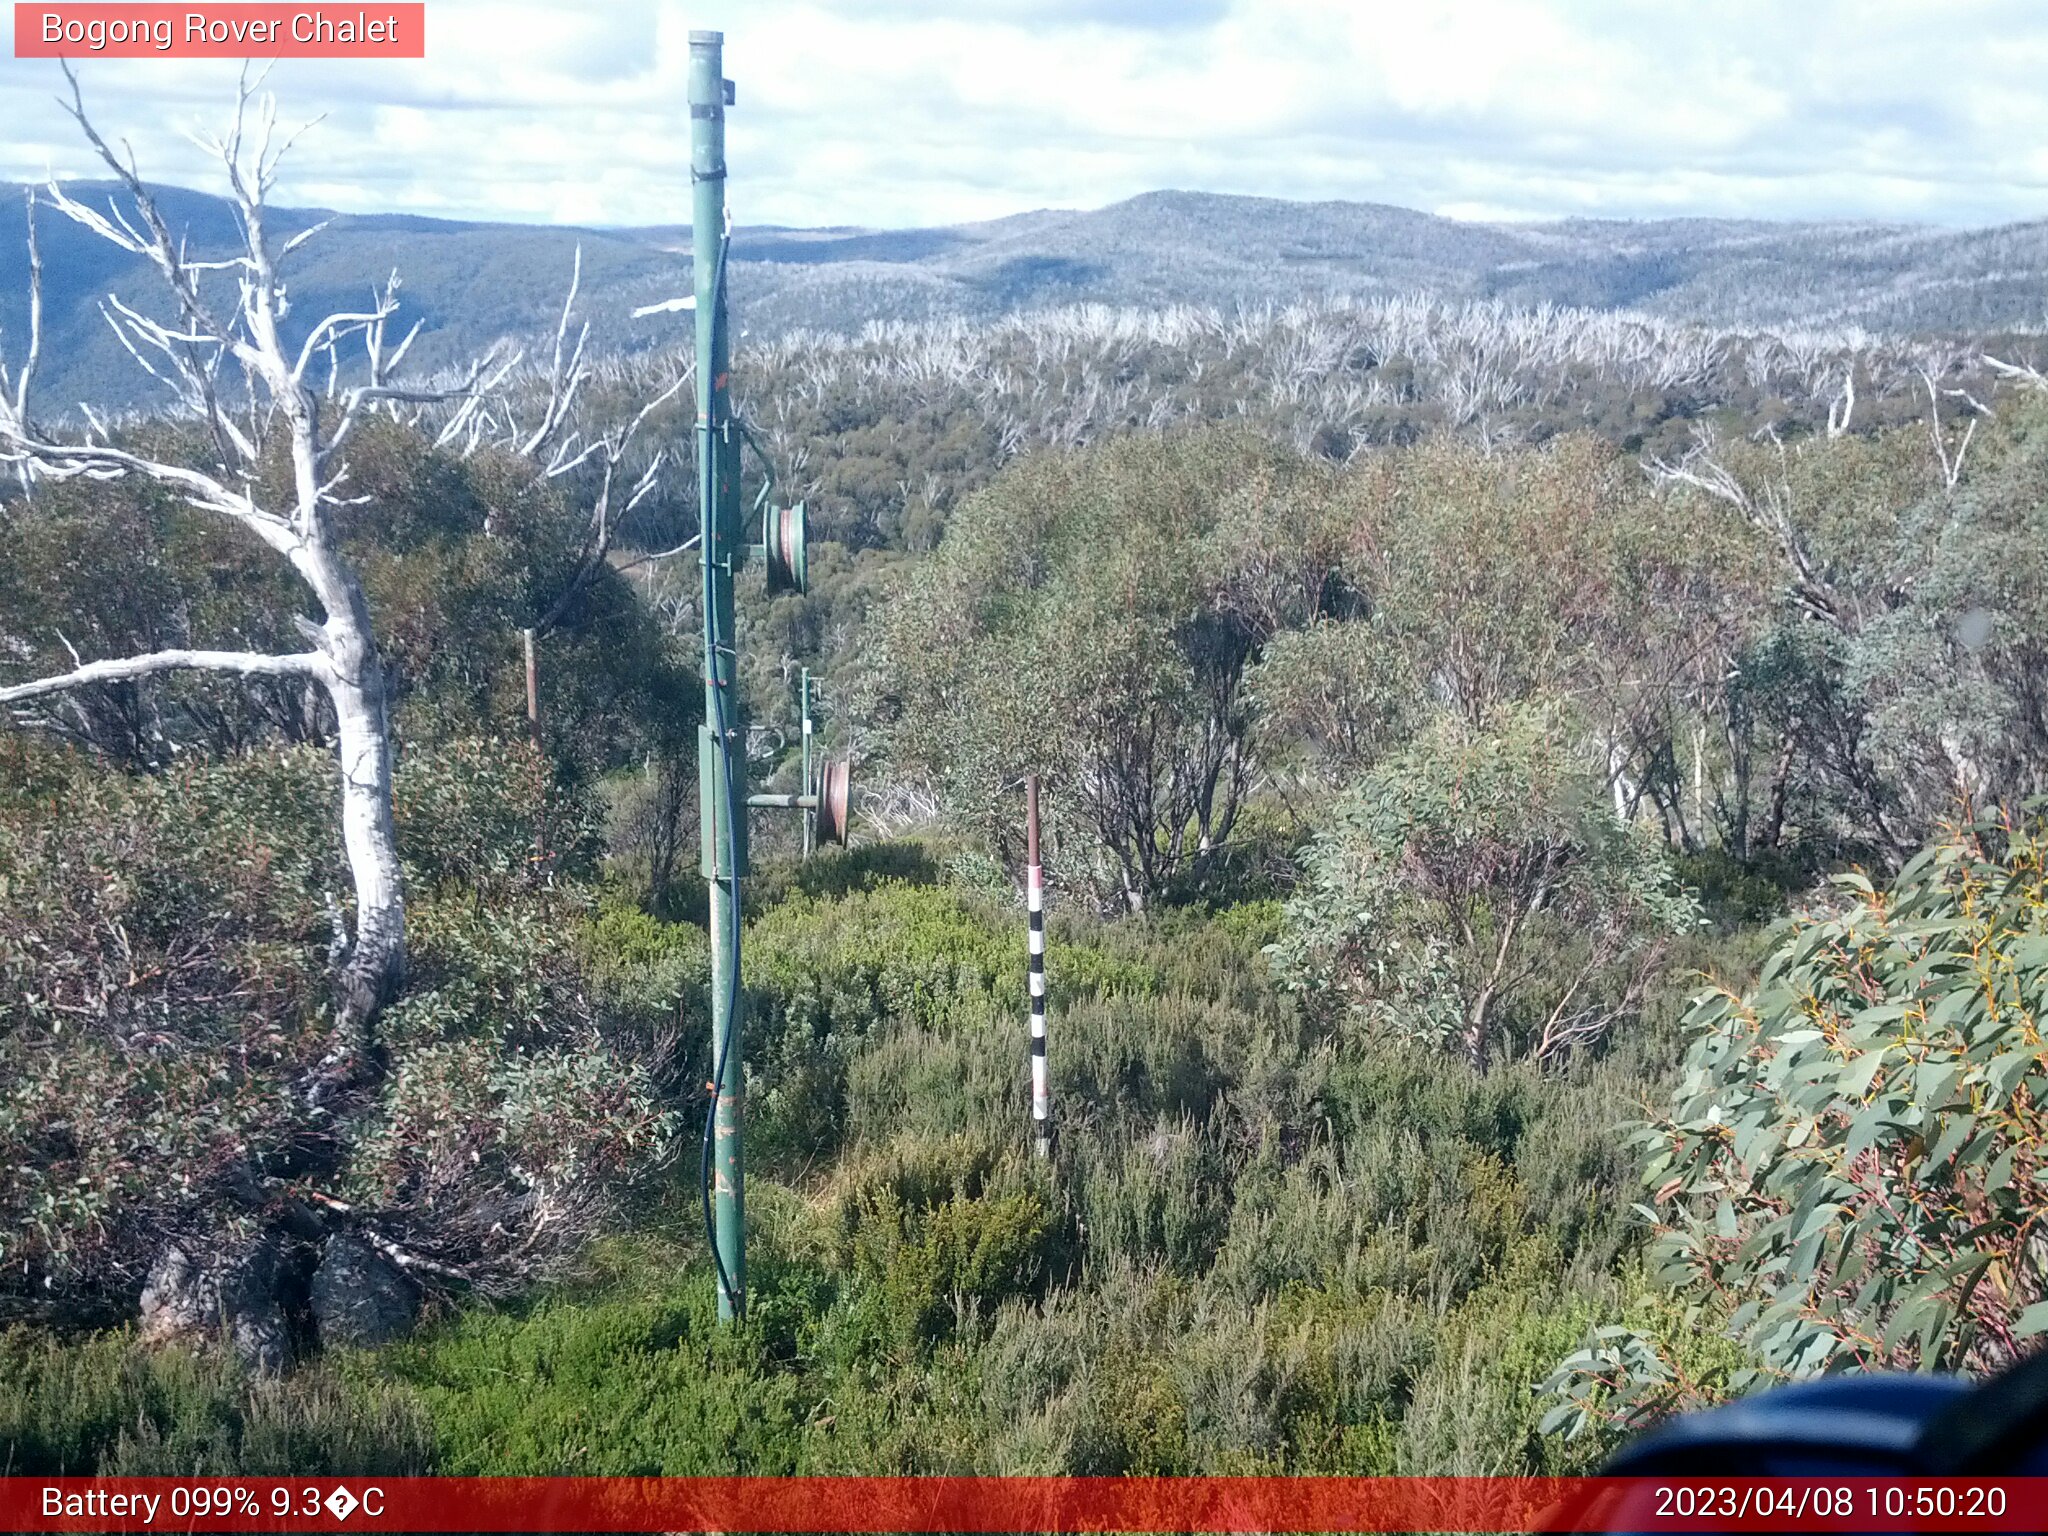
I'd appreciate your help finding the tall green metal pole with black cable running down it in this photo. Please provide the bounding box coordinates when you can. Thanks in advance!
[688,33,748,1319]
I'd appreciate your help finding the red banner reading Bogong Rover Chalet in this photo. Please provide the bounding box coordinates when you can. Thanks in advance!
[14,0,426,59]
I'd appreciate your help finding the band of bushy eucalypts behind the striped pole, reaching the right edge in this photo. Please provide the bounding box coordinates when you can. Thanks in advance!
[844,401,2048,913]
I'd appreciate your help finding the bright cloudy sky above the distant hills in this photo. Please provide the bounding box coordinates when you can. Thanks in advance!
[0,0,2048,227]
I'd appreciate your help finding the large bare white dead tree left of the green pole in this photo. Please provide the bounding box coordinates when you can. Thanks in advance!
[0,66,516,1104]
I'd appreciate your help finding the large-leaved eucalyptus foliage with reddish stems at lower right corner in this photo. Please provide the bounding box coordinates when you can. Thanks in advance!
[1556,817,2048,1427]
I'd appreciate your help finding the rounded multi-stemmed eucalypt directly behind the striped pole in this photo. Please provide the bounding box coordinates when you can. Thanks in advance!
[868,432,1335,909]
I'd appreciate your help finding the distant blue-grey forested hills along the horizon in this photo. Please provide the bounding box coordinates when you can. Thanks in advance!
[0,186,2048,406]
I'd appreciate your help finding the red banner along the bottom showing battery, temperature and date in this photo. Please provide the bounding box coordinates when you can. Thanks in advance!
[0,1477,2048,1532]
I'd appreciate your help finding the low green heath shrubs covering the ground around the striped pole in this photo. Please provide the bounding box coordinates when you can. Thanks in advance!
[0,860,1687,1475]
